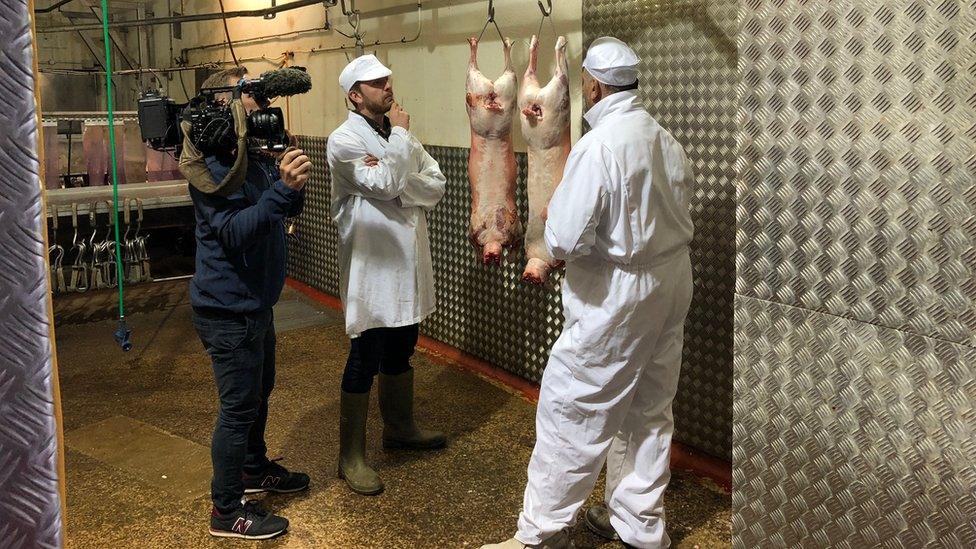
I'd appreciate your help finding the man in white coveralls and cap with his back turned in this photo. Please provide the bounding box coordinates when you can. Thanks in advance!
[485,37,694,549]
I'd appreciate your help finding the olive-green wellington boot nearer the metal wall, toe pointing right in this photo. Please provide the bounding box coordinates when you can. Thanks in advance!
[379,370,447,450]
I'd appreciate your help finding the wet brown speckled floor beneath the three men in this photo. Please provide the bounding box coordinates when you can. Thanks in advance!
[55,282,731,548]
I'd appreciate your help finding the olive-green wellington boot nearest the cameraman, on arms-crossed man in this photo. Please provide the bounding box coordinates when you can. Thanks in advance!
[339,391,383,496]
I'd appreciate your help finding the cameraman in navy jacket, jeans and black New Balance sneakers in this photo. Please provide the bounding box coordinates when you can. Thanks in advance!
[180,67,312,539]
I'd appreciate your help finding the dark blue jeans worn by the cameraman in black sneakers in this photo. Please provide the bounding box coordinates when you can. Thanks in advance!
[193,310,275,513]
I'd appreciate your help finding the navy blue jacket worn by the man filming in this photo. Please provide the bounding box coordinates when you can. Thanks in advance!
[190,155,305,313]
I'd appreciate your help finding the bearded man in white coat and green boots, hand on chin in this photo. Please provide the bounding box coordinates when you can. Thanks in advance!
[328,55,446,495]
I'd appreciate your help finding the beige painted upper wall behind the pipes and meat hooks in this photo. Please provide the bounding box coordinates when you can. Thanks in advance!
[173,0,582,149]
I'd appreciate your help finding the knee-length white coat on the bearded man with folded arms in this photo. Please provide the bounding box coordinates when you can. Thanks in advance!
[327,112,447,338]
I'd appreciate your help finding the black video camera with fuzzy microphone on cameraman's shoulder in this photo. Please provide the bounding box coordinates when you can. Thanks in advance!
[138,67,312,156]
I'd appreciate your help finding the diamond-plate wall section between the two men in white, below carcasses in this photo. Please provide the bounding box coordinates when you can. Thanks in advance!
[423,147,563,381]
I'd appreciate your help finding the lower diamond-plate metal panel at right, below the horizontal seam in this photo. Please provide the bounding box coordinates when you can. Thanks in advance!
[732,296,976,549]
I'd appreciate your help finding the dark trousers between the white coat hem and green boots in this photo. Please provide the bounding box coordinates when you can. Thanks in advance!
[342,324,420,393]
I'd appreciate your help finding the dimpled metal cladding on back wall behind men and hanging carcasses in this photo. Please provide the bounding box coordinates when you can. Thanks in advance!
[289,1,736,459]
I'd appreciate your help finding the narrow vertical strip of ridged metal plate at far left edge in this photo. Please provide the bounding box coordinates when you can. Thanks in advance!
[0,0,61,548]
